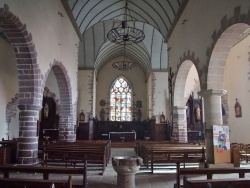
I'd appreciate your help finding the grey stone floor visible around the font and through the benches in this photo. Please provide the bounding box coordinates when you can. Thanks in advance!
[2,148,250,188]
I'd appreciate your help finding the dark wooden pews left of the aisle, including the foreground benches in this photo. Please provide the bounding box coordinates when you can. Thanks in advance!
[0,140,111,188]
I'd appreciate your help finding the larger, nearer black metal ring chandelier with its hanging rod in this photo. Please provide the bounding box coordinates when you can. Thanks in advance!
[107,1,145,45]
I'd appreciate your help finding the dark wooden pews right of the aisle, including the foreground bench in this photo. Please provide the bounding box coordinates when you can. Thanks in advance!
[134,141,250,188]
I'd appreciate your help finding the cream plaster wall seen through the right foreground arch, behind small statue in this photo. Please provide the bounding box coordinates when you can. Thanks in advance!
[224,36,250,144]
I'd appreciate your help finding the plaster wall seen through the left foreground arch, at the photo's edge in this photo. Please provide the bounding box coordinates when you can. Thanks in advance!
[0,37,19,139]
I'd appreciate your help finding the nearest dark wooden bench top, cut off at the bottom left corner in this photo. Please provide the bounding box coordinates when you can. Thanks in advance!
[0,176,72,188]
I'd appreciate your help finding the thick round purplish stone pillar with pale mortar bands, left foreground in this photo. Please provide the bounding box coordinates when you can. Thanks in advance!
[17,105,41,164]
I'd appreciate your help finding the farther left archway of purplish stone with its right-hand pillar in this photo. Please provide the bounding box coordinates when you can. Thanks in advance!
[44,60,76,142]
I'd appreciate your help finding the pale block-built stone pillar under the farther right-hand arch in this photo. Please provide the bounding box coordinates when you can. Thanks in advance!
[172,106,187,143]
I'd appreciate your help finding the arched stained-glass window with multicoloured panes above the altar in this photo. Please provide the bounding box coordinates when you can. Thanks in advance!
[110,77,132,121]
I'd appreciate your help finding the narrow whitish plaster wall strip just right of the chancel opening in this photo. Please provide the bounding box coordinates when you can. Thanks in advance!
[154,72,169,123]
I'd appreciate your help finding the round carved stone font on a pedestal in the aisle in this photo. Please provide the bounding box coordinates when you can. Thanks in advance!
[112,156,142,188]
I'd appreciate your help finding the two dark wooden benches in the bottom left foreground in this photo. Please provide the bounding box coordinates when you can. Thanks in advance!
[0,164,88,188]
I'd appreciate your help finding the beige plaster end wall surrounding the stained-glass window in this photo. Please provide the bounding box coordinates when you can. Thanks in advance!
[96,58,147,120]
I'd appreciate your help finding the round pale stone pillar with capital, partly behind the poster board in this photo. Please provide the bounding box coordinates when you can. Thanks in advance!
[198,89,226,164]
